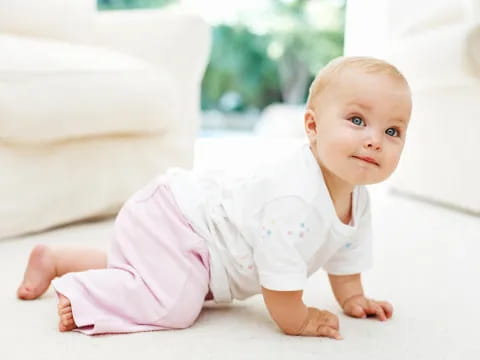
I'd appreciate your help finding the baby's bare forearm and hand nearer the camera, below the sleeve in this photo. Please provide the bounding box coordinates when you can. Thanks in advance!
[262,288,341,340]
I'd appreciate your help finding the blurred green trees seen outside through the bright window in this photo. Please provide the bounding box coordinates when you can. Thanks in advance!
[98,0,346,112]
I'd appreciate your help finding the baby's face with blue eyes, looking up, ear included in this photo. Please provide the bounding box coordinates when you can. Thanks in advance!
[305,69,411,185]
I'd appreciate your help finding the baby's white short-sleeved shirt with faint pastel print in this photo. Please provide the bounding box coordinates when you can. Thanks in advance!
[167,145,371,302]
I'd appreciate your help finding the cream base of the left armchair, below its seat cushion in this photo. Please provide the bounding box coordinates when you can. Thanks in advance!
[0,135,191,239]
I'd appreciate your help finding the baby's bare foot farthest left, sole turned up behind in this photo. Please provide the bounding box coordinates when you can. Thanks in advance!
[17,245,55,300]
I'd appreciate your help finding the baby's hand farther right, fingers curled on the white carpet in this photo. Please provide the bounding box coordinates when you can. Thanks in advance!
[343,295,393,321]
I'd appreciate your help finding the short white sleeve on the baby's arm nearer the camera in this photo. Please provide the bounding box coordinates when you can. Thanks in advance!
[254,197,309,291]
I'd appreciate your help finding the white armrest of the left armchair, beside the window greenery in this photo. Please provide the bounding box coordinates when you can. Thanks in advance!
[93,9,211,83]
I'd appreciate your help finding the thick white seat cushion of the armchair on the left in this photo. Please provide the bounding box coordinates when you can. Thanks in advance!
[0,35,178,143]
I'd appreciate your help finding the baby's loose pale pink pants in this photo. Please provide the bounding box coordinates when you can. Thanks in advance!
[53,178,210,334]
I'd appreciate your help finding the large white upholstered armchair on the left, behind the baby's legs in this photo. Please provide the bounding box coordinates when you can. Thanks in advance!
[0,0,210,238]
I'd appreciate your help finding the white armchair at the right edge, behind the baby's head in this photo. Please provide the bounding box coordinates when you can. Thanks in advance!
[345,0,480,215]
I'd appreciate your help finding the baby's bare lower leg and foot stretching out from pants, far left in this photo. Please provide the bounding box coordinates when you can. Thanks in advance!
[17,245,107,300]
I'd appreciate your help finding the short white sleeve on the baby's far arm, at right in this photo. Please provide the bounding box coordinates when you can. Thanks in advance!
[323,188,373,275]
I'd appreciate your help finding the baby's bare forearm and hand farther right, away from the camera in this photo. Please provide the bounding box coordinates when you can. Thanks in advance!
[328,274,393,321]
